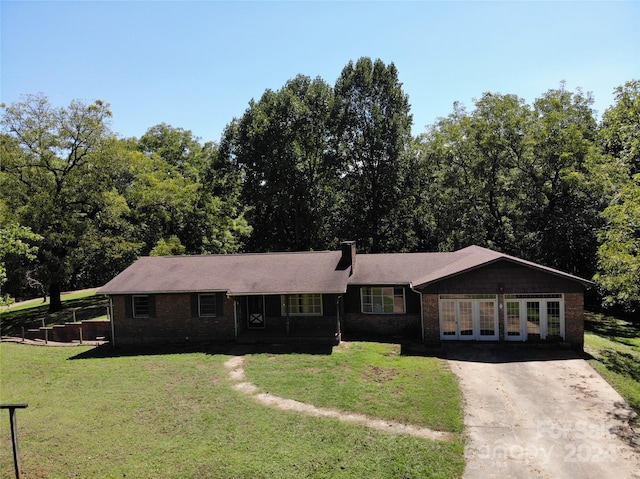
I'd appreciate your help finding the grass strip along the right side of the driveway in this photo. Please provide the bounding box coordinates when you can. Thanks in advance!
[584,312,640,414]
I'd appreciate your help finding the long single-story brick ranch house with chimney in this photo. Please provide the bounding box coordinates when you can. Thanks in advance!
[98,242,592,349]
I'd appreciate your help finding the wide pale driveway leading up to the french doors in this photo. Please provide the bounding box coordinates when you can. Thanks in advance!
[445,343,640,479]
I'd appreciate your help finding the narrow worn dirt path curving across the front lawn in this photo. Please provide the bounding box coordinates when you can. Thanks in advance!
[224,356,455,441]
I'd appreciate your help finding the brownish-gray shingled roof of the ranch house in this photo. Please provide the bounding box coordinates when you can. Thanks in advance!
[98,246,592,295]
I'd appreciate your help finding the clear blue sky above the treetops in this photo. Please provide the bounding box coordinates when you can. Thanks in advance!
[0,0,640,141]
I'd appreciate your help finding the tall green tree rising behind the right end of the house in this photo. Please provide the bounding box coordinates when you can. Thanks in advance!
[521,85,606,277]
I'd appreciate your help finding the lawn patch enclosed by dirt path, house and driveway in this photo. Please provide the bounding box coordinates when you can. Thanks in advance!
[245,343,463,432]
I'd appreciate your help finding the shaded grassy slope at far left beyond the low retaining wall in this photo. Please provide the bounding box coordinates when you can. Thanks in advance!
[0,290,109,336]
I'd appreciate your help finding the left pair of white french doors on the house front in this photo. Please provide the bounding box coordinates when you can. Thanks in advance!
[440,295,498,341]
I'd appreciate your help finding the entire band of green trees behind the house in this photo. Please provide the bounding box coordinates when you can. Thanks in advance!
[0,63,640,309]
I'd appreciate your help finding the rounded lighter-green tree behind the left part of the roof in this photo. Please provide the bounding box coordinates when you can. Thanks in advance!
[131,124,250,254]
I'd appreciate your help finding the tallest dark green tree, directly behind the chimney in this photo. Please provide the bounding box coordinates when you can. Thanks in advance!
[333,57,415,252]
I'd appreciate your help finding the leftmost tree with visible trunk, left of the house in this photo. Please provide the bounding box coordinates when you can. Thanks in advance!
[0,94,116,311]
